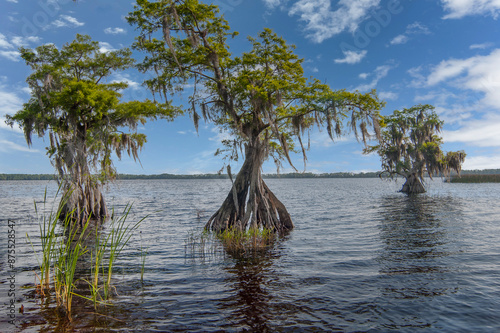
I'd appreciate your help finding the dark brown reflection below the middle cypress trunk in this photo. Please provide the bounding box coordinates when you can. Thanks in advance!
[218,249,279,332]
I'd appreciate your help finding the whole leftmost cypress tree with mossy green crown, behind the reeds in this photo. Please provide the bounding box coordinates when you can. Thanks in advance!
[7,35,177,220]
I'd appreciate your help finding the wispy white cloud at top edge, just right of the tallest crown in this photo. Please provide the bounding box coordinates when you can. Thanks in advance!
[290,0,380,43]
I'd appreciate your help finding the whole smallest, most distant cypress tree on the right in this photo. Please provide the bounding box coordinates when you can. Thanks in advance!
[365,104,466,193]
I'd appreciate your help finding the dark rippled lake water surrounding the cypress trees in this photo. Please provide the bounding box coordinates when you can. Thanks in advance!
[0,179,500,332]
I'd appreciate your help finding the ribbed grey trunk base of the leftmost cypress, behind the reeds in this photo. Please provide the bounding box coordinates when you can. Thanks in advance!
[60,179,109,226]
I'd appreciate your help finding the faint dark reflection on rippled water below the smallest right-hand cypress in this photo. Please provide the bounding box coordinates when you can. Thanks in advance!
[377,195,457,299]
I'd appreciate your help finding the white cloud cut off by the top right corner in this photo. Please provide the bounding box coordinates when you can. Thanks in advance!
[441,0,500,19]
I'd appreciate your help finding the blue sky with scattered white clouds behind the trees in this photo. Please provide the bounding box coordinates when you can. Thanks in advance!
[0,0,500,174]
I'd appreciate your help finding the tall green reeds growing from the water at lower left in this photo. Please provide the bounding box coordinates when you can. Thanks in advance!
[27,188,147,320]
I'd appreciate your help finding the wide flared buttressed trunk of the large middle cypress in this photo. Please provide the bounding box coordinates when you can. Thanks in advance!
[205,143,294,233]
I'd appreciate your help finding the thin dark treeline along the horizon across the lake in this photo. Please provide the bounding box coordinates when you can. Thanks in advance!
[0,169,500,183]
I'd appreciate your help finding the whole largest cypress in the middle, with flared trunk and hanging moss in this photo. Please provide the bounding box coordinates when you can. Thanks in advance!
[128,0,384,231]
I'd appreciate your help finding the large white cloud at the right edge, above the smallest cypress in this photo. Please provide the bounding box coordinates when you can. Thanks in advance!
[427,49,500,109]
